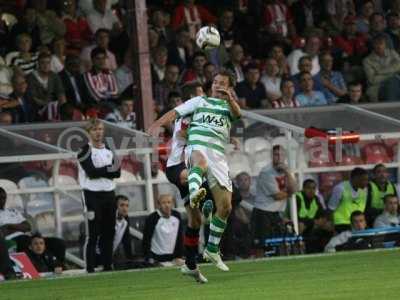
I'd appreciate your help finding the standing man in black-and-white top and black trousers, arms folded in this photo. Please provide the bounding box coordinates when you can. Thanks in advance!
[78,119,121,273]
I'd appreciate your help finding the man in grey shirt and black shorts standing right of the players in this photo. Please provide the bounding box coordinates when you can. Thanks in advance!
[251,145,296,255]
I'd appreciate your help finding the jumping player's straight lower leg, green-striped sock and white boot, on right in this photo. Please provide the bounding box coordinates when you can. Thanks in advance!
[203,185,232,271]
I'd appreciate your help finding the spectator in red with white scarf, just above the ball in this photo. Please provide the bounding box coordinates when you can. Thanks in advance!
[171,0,217,40]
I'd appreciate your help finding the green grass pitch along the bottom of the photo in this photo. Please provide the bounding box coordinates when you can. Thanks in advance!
[0,250,400,300]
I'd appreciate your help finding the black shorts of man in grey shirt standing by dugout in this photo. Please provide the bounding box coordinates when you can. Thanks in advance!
[251,208,283,248]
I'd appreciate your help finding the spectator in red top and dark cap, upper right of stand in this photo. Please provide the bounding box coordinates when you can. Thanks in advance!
[333,16,368,65]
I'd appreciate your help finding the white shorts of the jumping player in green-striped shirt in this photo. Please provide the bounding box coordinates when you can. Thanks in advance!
[185,145,233,192]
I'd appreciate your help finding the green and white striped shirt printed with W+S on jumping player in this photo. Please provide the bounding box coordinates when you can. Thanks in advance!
[175,97,235,153]
